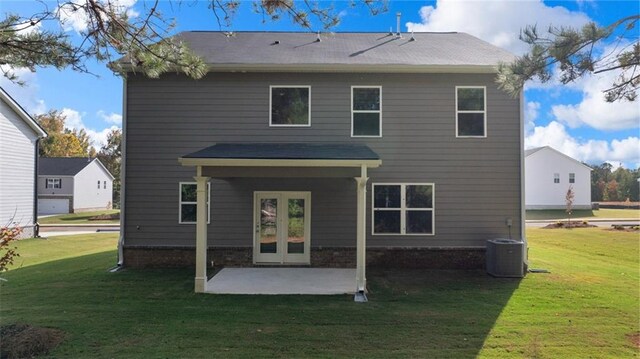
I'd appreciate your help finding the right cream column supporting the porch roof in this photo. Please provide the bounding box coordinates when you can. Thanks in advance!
[355,166,369,292]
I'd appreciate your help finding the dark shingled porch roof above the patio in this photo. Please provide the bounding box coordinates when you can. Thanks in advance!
[183,143,380,160]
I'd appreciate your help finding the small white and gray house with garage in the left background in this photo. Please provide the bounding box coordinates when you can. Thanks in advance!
[38,157,113,215]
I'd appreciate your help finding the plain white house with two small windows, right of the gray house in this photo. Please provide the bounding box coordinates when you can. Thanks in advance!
[524,146,591,209]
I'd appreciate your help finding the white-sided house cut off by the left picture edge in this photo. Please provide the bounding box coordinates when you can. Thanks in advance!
[0,88,47,237]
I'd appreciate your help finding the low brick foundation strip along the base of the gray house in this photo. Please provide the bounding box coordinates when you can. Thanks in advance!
[124,247,485,269]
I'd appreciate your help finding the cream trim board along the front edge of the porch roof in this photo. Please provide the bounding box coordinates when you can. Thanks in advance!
[178,157,382,168]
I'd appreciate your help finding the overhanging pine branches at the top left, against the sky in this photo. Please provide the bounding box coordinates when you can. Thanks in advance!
[0,0,386,82]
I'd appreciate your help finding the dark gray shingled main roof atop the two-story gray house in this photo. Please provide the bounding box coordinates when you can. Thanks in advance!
[165,31,514,68]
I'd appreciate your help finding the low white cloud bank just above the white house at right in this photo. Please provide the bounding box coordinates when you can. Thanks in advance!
[525,121,640,168]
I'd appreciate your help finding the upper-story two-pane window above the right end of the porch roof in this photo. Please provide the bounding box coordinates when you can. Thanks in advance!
[351,86,382,137]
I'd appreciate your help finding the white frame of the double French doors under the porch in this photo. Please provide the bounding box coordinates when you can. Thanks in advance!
[251,191,311,265]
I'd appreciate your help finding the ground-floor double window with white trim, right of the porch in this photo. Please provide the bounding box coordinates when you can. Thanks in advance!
[371,183,435,235]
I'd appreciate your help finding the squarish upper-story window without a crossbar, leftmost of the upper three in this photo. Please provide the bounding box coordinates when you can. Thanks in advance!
[269,86,311,127]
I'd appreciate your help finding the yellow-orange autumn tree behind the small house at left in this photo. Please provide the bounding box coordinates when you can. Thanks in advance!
[35,110,96,157]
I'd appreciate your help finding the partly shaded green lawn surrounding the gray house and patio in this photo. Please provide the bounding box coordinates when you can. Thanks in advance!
[0,229,640,358]
